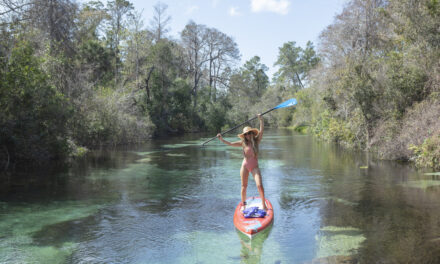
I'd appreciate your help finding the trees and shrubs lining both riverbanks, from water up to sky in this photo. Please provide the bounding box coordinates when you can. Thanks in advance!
[0,0,440,172]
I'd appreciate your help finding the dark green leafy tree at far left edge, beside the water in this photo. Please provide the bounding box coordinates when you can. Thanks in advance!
[0,41,70,169]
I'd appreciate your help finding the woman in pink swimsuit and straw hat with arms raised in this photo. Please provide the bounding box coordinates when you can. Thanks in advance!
[217,114,267,211]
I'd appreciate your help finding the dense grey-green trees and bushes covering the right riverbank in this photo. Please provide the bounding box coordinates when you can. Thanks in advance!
[294,0,440,168]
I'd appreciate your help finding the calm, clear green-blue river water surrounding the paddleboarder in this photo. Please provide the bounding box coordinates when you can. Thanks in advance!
[0,130,440,263]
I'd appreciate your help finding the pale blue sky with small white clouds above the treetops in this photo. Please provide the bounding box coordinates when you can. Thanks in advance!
[127,0,347,78]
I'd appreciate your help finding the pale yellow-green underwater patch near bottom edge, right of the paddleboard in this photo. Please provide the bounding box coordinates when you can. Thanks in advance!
[316,226,366,258]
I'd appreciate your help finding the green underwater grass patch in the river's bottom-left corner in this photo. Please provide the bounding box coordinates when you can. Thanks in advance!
[0,201,103,263]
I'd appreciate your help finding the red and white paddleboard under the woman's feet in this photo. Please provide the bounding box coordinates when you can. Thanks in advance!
[234,197,273,238]
